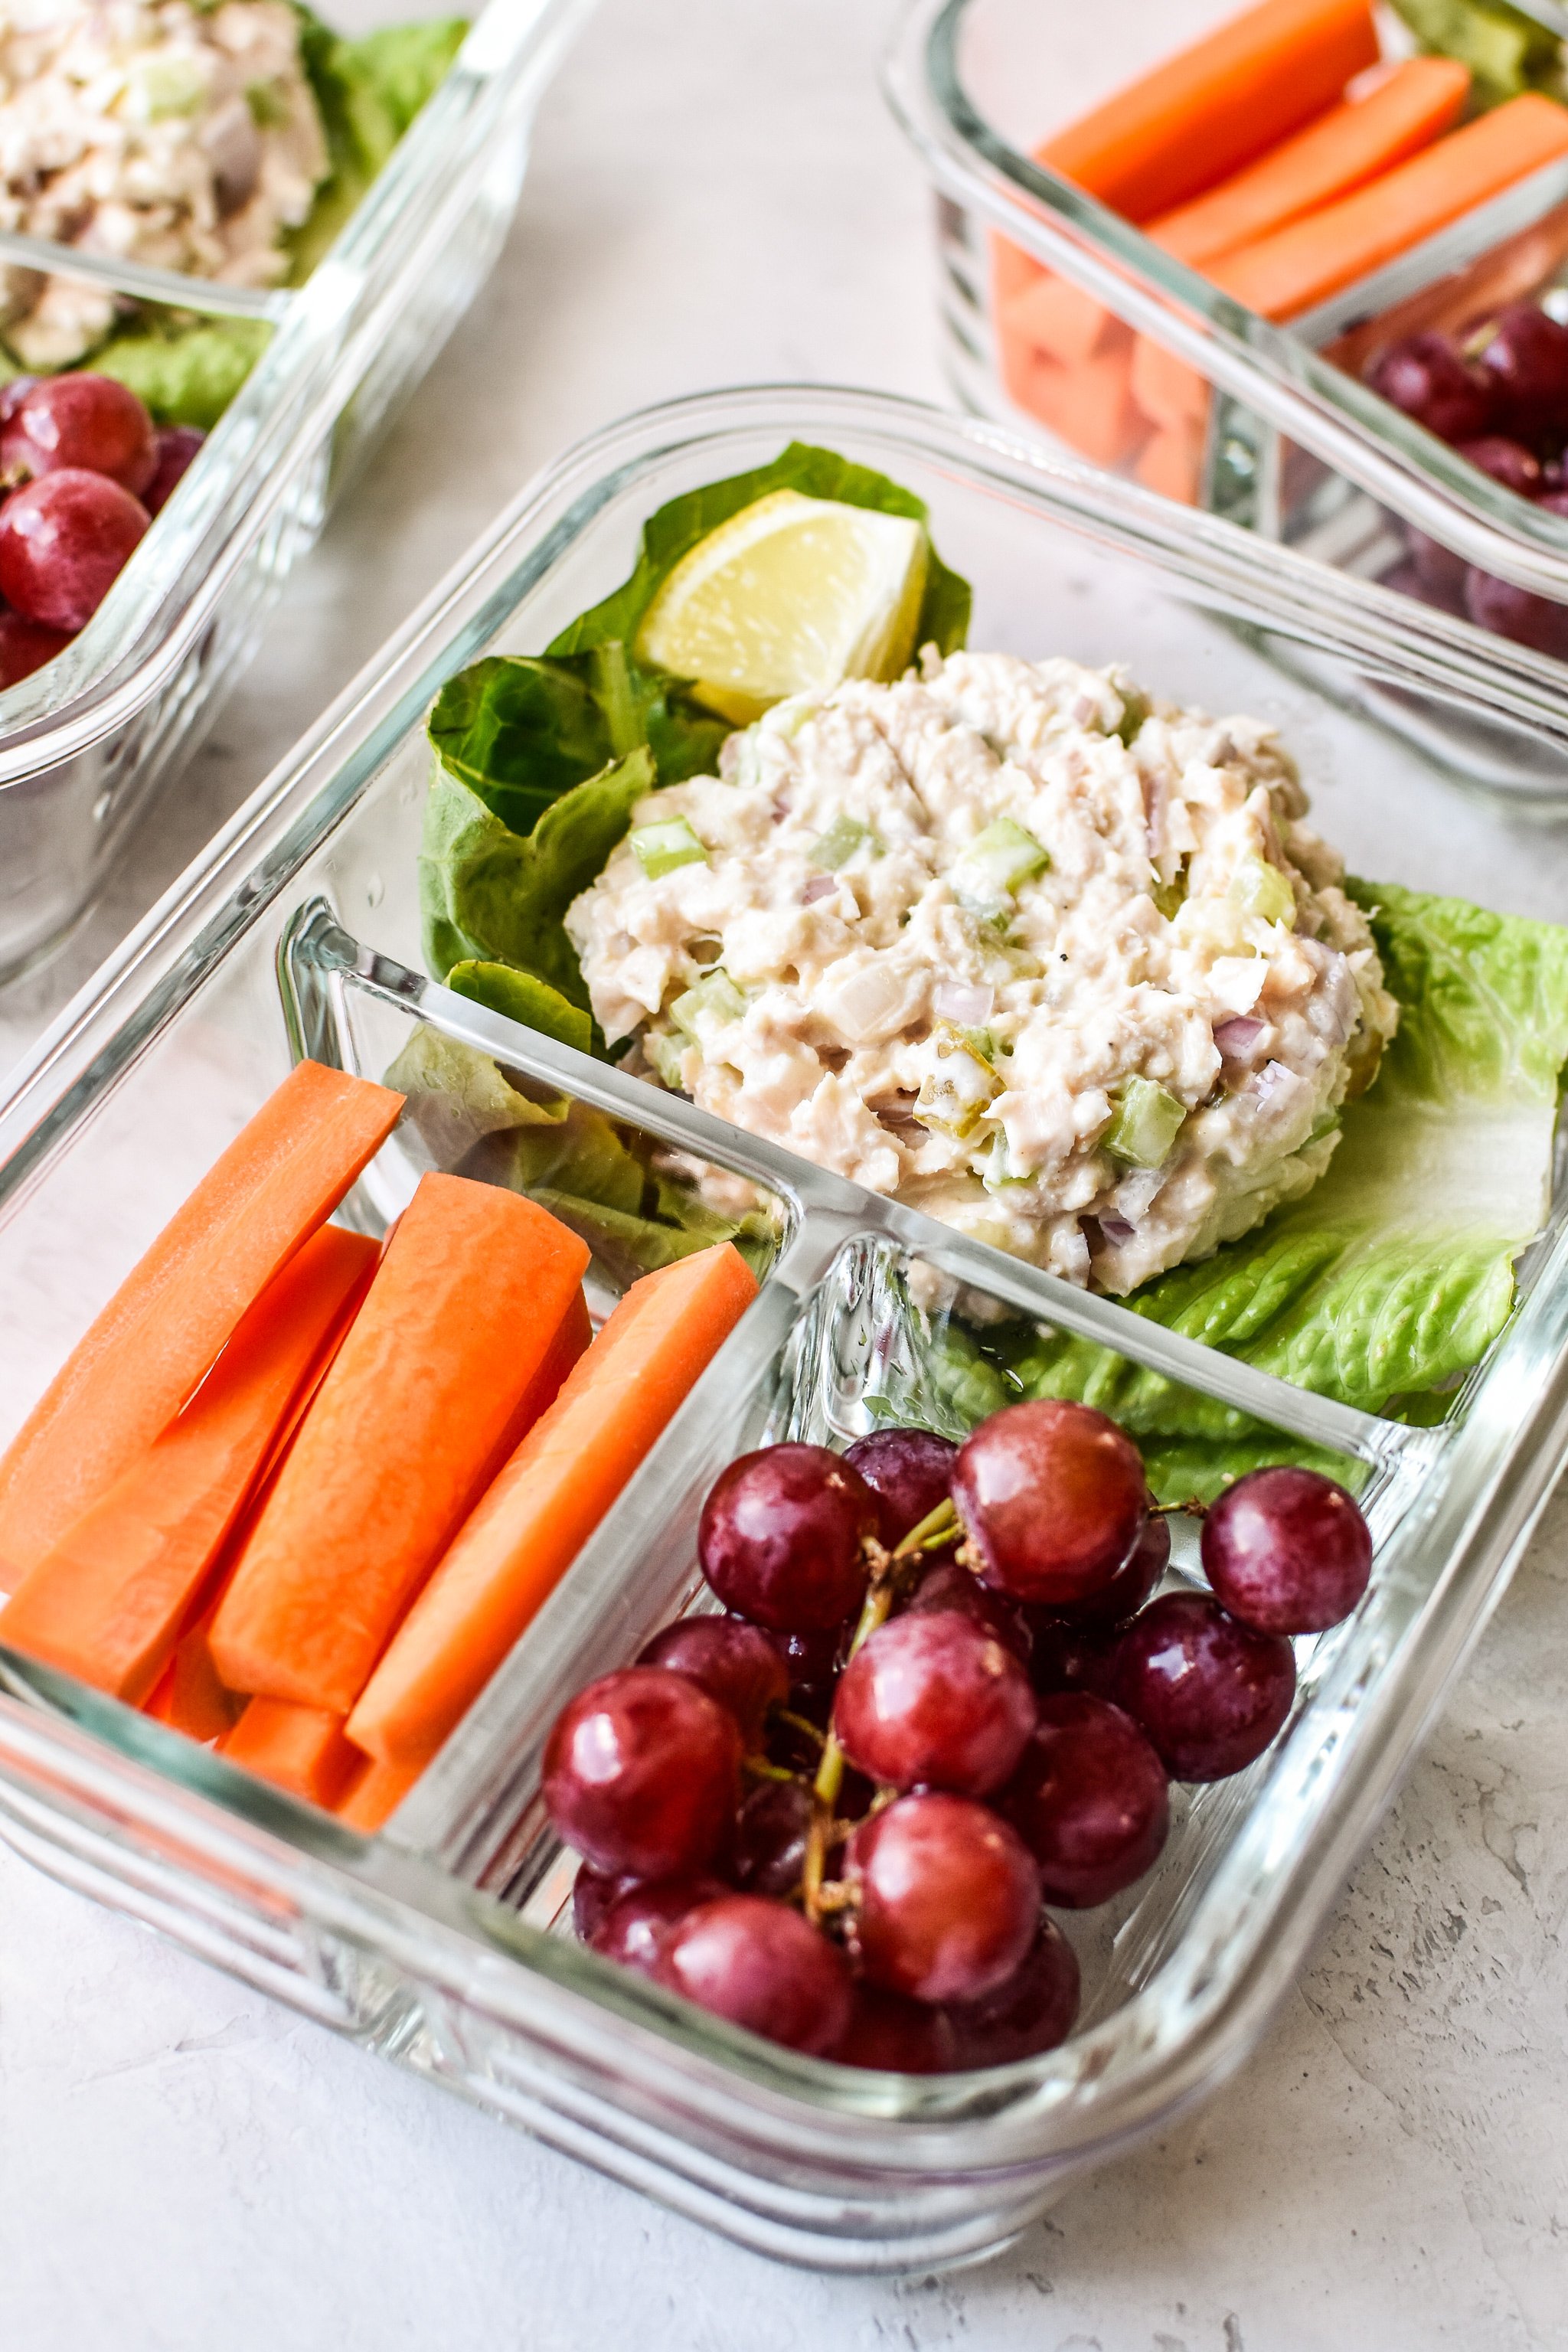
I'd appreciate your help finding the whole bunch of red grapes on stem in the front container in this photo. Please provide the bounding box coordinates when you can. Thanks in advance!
[543,1402,1373,2075]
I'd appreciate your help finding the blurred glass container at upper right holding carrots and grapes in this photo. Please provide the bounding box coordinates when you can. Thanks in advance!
[887,0,1568,802]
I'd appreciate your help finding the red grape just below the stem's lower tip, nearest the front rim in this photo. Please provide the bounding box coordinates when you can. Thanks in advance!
[656,1896,851,2058]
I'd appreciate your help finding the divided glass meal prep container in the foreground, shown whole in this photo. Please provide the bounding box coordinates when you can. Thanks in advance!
[0,388,1568,2269]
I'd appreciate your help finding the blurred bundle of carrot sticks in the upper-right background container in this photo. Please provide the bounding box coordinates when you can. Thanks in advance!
[992,0,1568,503]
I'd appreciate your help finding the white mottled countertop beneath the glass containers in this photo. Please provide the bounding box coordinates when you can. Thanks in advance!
[0,0,1568,2352]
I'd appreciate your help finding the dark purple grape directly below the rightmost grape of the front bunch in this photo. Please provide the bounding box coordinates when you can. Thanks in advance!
[1112,1592,1295,1781]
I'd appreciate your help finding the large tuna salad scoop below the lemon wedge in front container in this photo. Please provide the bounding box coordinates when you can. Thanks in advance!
[567,652,1399,1294]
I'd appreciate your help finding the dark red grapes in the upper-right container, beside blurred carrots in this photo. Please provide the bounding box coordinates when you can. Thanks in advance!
[1366,301,1568,661]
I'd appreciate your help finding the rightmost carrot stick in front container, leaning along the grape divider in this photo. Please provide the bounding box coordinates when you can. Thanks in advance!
[348,1242,757,1764]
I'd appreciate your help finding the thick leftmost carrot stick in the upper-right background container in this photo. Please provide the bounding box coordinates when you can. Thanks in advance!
[1037,0,1377,221]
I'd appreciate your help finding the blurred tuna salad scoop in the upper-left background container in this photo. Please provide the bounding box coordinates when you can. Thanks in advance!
[0,0,327,367]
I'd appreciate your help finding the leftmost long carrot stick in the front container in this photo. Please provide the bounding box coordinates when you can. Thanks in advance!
[0,1060,402,1592]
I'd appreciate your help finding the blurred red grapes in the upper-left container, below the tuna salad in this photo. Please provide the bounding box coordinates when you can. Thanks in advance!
[0,374,204,687]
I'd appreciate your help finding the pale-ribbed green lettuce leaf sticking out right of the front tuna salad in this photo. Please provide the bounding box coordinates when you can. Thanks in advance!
[980,884,1568,1494]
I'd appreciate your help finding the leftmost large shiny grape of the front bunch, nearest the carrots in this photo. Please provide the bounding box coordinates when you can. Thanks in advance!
[543,1665,740,1880]
